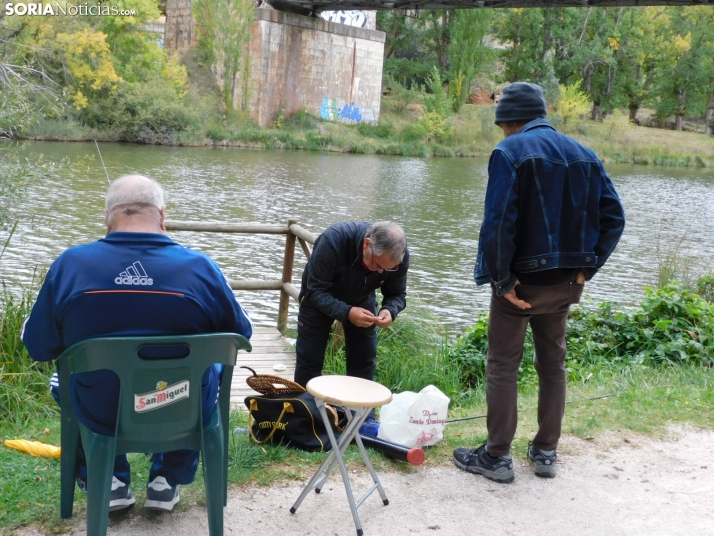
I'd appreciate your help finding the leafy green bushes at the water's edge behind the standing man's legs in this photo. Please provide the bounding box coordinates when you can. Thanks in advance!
[449,276,714,386]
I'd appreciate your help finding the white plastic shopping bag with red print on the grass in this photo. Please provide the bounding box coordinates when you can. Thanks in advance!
[377,385,450,447]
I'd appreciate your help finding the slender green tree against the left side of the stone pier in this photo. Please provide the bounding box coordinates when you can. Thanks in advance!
[193,0,255,121]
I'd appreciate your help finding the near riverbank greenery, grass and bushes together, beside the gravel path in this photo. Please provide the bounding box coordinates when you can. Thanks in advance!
[0,277,714,534]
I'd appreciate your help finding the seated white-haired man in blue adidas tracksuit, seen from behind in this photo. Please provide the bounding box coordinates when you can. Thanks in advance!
[22,175,253,511]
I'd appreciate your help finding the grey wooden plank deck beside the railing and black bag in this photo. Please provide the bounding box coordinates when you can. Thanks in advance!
[231,327,295,410]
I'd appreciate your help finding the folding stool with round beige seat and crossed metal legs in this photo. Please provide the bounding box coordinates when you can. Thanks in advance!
[290,376,392,536]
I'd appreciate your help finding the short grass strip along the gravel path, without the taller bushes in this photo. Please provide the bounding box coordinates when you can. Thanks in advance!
[0,360,714,533]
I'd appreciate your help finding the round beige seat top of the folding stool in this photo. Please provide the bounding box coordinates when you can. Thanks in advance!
[306,376,392,408]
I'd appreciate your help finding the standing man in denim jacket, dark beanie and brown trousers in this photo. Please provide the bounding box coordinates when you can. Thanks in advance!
[454,82,625,483]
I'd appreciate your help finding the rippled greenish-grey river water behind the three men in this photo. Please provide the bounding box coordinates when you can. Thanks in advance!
[0,142,714,334]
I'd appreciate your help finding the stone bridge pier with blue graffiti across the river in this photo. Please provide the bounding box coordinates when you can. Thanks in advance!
[164,0,385,127]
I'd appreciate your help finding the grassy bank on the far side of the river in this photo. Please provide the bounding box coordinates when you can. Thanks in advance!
[25,97,714,167]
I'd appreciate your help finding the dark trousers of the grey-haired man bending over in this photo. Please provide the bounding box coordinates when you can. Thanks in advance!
[295,301,377,387]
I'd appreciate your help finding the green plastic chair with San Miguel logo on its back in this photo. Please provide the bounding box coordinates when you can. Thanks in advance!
[57,333,252,536]
